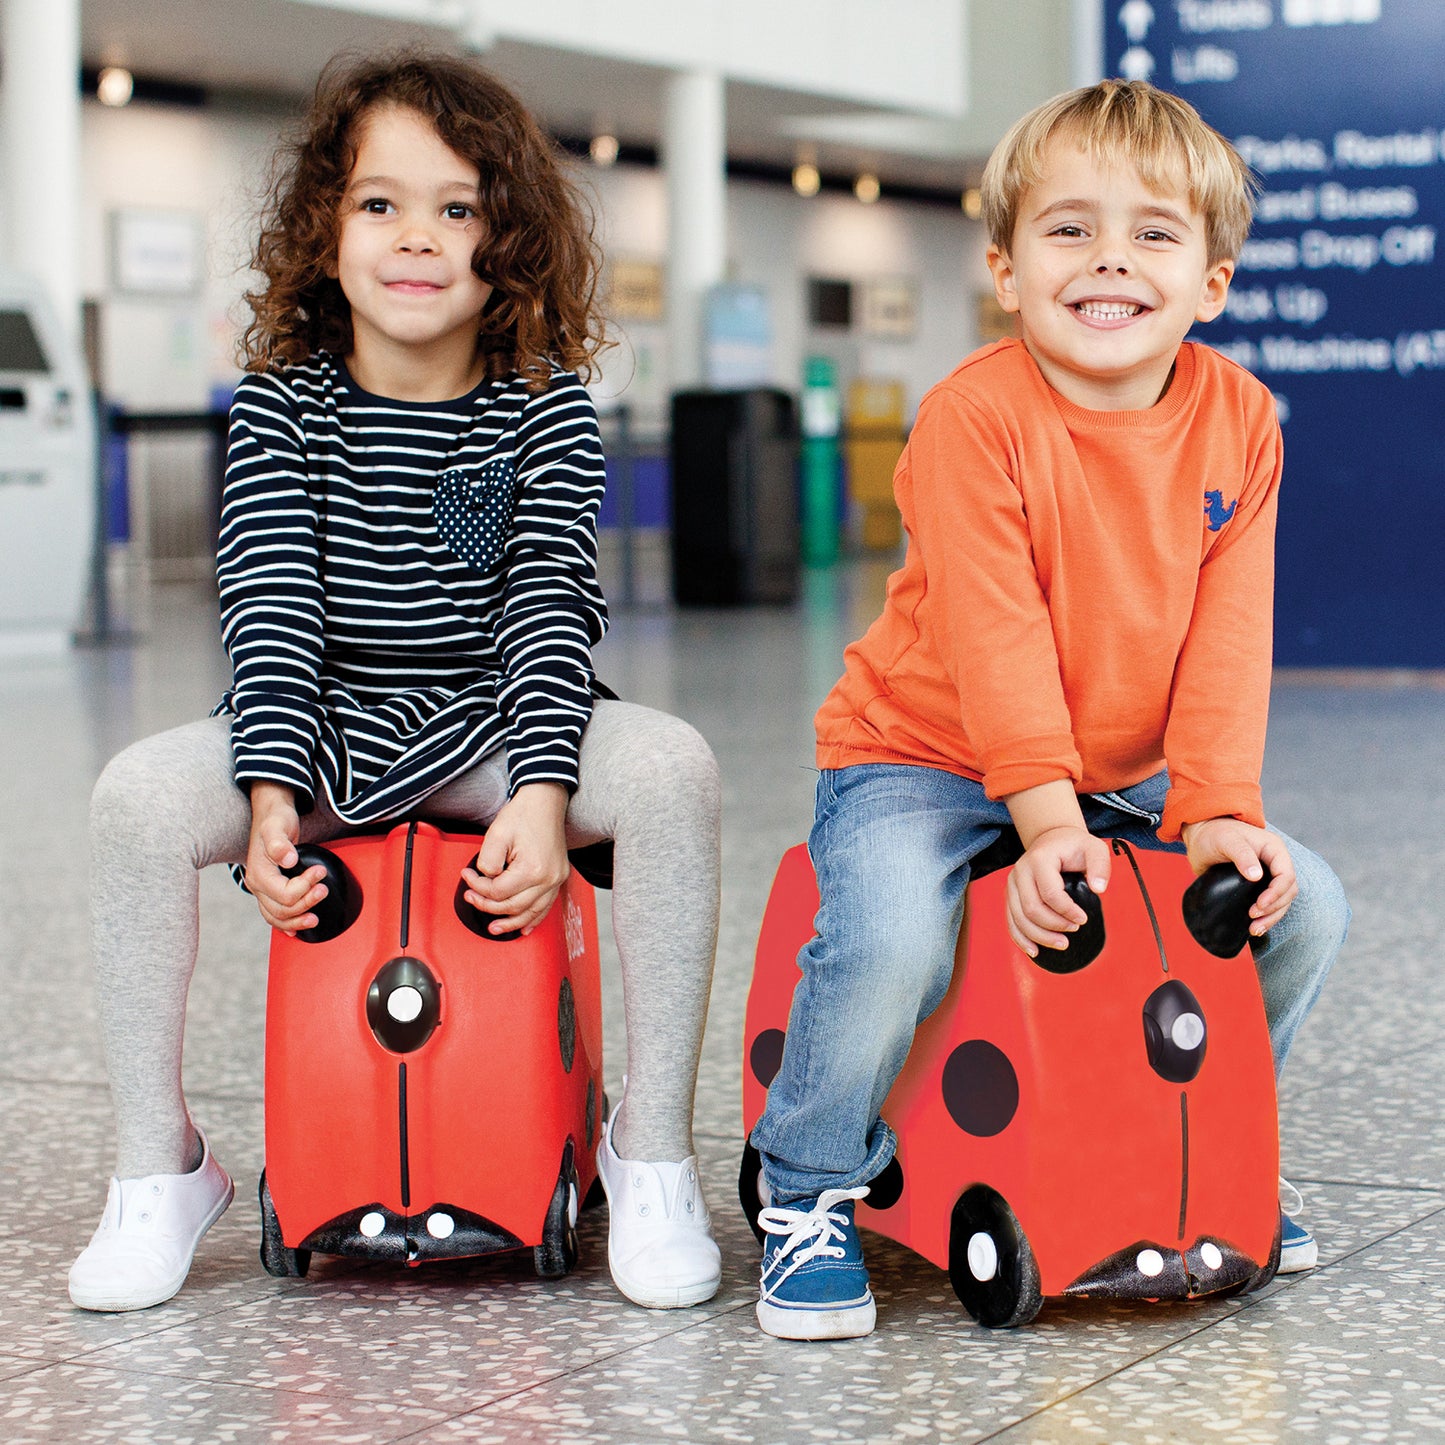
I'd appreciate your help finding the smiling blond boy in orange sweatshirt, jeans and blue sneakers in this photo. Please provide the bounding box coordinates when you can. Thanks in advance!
[753,81,1350,1340]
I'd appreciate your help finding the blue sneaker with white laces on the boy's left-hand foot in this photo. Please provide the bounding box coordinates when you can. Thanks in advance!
[757,1188,876,1340]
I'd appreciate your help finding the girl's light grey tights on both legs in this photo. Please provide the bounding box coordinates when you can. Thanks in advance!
[91,699,720,1179]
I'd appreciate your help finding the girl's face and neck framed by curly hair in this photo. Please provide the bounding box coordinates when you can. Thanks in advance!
[331,104,491,400]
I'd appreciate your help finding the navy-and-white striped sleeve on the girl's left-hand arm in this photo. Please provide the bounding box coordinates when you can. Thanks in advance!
[215,376,324,812]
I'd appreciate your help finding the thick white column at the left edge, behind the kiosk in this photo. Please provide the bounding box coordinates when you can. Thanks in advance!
[0,0,81,340]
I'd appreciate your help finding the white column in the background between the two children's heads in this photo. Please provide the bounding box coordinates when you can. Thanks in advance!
[662,71,727,389]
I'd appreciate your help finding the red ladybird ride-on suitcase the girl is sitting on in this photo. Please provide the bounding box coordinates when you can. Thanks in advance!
[260,822,605,1277]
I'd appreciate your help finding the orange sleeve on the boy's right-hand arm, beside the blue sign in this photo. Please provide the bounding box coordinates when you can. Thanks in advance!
[1159,397,1283,842]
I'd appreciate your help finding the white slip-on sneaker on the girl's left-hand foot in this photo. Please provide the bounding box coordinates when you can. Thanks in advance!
[71,1130,236,1311]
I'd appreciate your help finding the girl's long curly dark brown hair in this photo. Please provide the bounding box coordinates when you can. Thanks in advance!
[240,49,607,390]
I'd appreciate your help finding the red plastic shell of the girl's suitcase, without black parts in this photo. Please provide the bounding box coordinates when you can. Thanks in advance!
[266,824,603,1248]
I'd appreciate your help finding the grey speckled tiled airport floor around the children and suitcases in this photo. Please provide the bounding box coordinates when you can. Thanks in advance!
[0,566,1445,1445]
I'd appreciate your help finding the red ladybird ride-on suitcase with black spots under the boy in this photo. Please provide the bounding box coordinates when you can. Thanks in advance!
[738,841,1280,1325]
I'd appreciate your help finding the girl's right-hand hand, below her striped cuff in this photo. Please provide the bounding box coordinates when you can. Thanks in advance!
[461,783,569,933]
